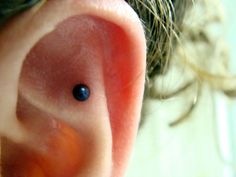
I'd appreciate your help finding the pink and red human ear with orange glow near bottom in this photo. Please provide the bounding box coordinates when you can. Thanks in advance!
[0,0,146,177]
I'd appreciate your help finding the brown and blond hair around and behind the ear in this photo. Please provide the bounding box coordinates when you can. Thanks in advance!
[0,0,236,126]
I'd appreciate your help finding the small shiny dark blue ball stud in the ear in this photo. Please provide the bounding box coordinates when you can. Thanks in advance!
[73,84,90,101]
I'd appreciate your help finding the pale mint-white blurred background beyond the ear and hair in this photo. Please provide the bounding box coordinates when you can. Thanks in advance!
[126,0,236,177]
